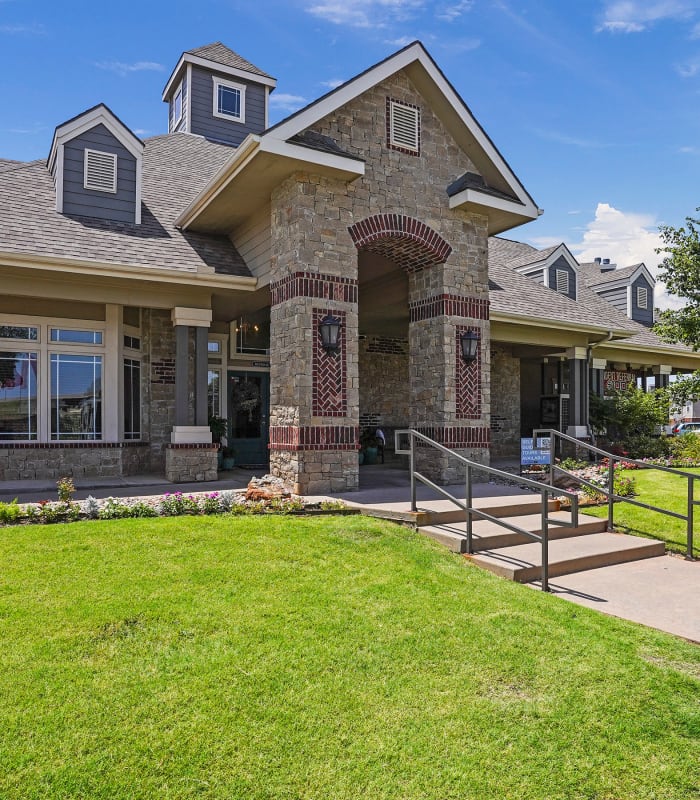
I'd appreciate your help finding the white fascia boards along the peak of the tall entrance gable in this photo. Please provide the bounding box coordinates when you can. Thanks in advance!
[272,42,539,219]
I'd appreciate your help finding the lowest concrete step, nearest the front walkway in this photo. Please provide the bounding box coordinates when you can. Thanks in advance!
[468,533,666,583]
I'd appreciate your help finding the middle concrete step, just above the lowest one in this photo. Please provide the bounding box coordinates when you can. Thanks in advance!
[419,511,607,553]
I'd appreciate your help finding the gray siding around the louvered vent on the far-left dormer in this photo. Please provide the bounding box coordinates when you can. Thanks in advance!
[63,124,136,223]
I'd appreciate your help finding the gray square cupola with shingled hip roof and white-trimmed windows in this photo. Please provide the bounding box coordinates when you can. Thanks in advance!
[163,42,277,147]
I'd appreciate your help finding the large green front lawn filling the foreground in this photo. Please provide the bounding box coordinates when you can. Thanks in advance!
[0,517,700,800]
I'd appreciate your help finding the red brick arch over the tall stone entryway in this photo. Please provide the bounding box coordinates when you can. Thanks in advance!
[348,214,452,272]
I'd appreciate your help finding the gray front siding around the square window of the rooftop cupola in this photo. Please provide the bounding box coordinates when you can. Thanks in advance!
[189,65,265,146]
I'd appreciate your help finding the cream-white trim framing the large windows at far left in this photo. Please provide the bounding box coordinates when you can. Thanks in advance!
[0,314,109,444]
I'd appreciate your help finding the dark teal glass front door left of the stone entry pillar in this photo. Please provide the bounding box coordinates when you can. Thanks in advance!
[228,370,270,466]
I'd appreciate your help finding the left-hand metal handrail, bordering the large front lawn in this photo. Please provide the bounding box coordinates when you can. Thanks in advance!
[394,429,578,592]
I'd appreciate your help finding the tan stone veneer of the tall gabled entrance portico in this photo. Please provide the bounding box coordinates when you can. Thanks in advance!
[270,72,490,492]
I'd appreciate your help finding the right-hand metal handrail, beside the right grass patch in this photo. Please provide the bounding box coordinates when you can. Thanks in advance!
[532,428,700,561]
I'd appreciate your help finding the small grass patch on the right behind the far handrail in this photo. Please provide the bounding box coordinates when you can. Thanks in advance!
[586,469,700,558]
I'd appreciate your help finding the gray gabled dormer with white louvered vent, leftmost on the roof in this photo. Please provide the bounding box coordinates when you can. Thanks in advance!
[47,104,144,225]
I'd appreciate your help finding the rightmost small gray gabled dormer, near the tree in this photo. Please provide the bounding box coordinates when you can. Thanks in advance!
[586,259,656,327]
